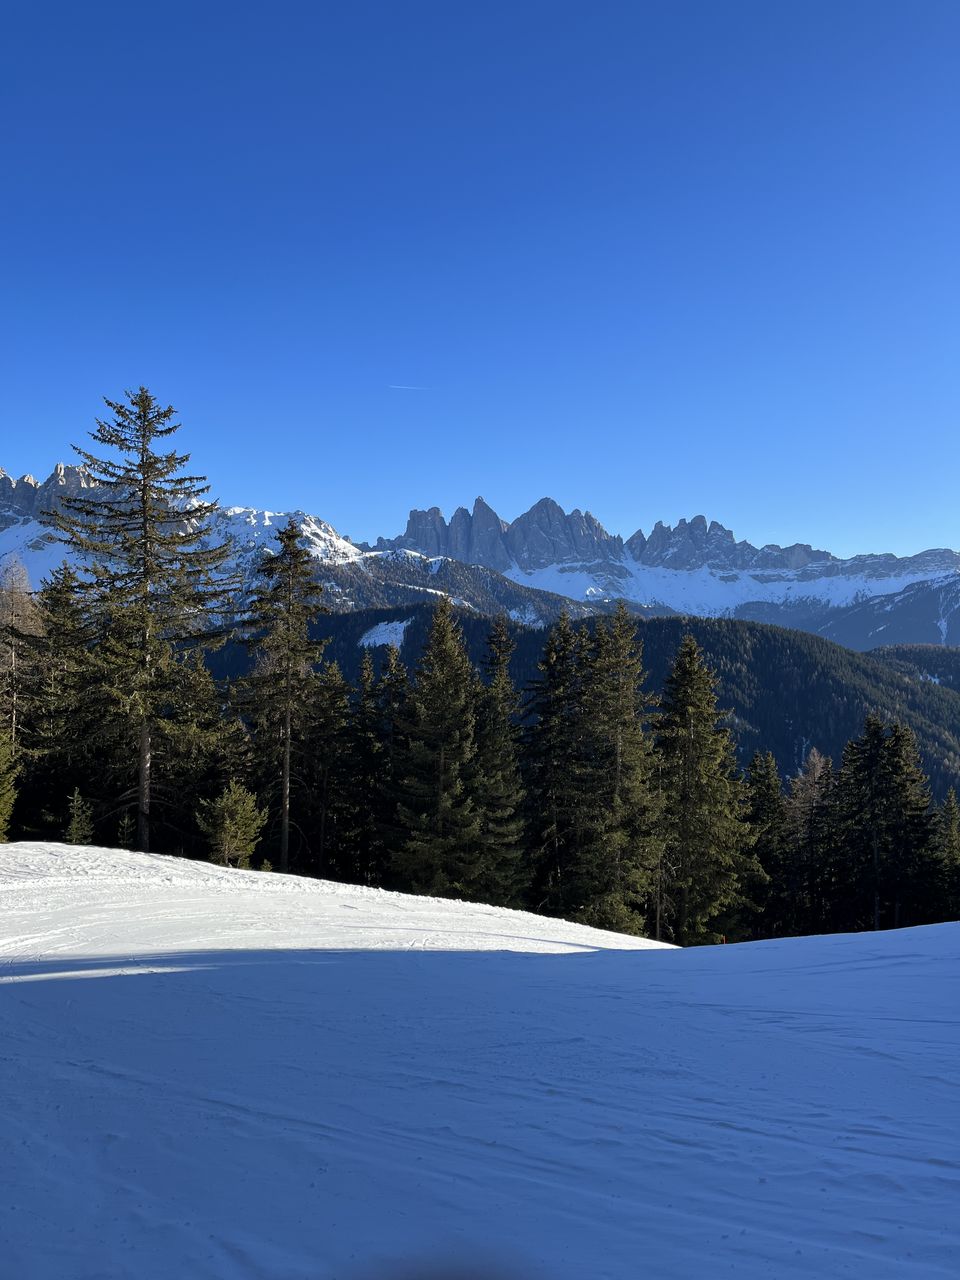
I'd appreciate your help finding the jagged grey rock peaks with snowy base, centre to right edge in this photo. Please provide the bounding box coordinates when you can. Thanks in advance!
[378,498,960,649]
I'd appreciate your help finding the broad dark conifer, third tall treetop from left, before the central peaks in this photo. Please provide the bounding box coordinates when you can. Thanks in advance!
[393,596,481,897]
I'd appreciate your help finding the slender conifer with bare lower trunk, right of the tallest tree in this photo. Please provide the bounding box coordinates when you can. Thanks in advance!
[244,518,324,872]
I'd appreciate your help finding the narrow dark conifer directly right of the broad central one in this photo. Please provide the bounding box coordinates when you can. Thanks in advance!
[474,617,530,906]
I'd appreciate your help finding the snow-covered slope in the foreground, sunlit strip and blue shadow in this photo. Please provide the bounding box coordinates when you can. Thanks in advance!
[0,845,960,1280]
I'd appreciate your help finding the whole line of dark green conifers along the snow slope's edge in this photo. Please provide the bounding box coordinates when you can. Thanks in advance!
[0,388,960,945]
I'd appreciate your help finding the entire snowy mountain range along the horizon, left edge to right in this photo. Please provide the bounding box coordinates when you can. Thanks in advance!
[0,465,960,649]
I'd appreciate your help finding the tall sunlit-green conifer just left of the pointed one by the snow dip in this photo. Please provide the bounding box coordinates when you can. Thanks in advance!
[571,604,662,933]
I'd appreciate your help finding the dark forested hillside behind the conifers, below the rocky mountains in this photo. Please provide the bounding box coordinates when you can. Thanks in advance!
[210,605,960,799]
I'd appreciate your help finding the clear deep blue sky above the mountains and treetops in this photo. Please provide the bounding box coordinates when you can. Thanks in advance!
[0,0,960,554]
